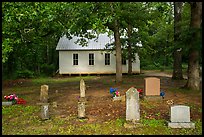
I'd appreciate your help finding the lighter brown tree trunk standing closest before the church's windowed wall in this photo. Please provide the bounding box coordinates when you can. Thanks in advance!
[114,20,122,83]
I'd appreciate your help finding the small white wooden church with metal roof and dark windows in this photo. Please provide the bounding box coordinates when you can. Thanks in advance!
[56,33,140,75]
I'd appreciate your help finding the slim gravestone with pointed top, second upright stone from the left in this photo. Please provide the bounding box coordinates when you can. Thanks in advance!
[78,79,86,118]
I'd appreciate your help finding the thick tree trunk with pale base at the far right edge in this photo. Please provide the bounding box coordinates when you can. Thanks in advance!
[185,2,202,90]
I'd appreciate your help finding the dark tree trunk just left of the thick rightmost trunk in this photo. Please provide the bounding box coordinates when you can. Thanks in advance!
[172,2,183,80]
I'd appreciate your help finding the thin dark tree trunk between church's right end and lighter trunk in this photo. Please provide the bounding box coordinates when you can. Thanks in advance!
[127,24,132,75]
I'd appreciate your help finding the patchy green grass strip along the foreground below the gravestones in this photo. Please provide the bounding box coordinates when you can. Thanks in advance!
[2,105,202,135]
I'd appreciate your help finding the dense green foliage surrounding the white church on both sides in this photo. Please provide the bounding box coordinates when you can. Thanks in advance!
[2,2,202,78]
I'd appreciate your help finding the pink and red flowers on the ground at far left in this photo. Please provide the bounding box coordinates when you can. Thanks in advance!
[4,94,26,104]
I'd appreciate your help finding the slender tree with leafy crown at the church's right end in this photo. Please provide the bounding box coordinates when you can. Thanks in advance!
[120,2,150,75]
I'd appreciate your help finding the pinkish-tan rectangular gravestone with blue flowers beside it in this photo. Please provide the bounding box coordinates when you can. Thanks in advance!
[144,77,161,99]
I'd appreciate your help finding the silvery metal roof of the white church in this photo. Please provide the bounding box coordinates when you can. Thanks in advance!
[56,33,114,50]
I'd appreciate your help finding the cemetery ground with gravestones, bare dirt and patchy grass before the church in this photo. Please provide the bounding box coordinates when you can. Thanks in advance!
[2,71,202,135]
